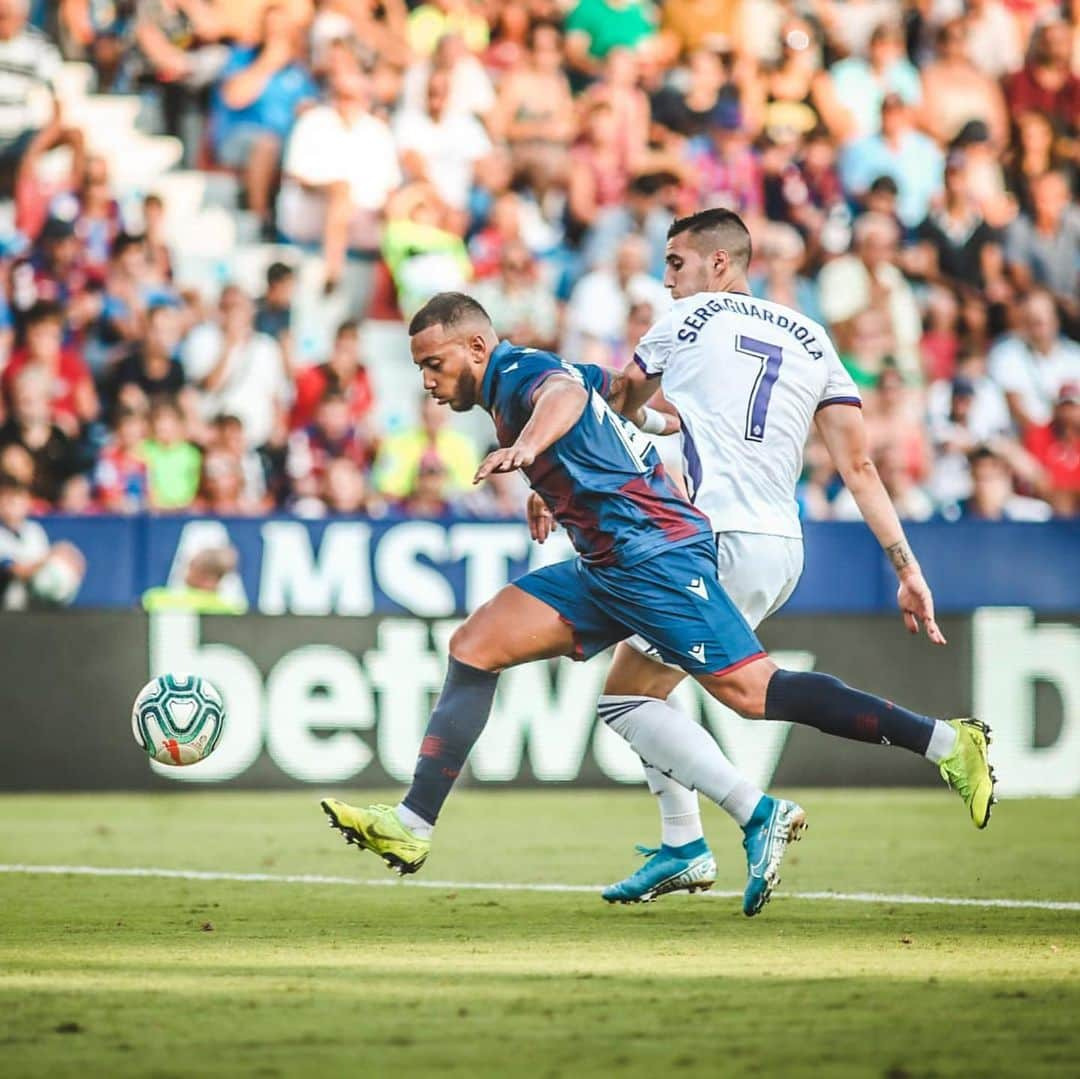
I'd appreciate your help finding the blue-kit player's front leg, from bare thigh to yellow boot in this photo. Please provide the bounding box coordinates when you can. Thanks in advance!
[322,584,575,874]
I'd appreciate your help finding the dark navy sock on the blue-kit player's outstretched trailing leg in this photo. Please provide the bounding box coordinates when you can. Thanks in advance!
[765,671,934,755]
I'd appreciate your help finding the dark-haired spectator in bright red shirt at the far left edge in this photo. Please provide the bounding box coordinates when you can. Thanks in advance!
[3,300,98,439]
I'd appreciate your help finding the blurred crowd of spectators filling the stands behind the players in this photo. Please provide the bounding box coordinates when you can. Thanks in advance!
[0,0,1080,520]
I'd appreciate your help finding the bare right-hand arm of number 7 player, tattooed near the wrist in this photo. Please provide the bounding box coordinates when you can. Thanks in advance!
[816,404,945,645]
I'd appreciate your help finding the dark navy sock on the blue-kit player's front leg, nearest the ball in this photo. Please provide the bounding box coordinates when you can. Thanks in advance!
[402,656,499,824]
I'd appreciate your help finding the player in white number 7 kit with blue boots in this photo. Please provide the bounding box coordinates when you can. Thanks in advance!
[530,210,993,915]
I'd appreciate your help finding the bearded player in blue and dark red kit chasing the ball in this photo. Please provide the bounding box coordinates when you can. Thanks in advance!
[322,293,993,911]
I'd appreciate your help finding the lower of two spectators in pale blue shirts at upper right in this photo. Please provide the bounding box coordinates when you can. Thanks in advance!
[840,93,945,229]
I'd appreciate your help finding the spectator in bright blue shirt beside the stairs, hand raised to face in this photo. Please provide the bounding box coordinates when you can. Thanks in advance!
[211,5,319,236]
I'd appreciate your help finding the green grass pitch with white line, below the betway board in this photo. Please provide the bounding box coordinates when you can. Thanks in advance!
[0,790,1080,1079]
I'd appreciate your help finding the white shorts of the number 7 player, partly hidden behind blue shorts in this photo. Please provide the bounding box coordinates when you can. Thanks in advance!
[626,532,802,666]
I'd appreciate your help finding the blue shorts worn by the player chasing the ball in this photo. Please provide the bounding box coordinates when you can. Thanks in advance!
[513,540,766,674]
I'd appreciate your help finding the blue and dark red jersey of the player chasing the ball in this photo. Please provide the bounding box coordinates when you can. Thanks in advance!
[481,341,712,566]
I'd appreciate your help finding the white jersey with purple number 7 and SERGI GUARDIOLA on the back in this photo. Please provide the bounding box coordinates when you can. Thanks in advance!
[634,293,862,539]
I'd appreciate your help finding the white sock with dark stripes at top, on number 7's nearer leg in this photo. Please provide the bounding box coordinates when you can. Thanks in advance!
[597,694,762,827]
